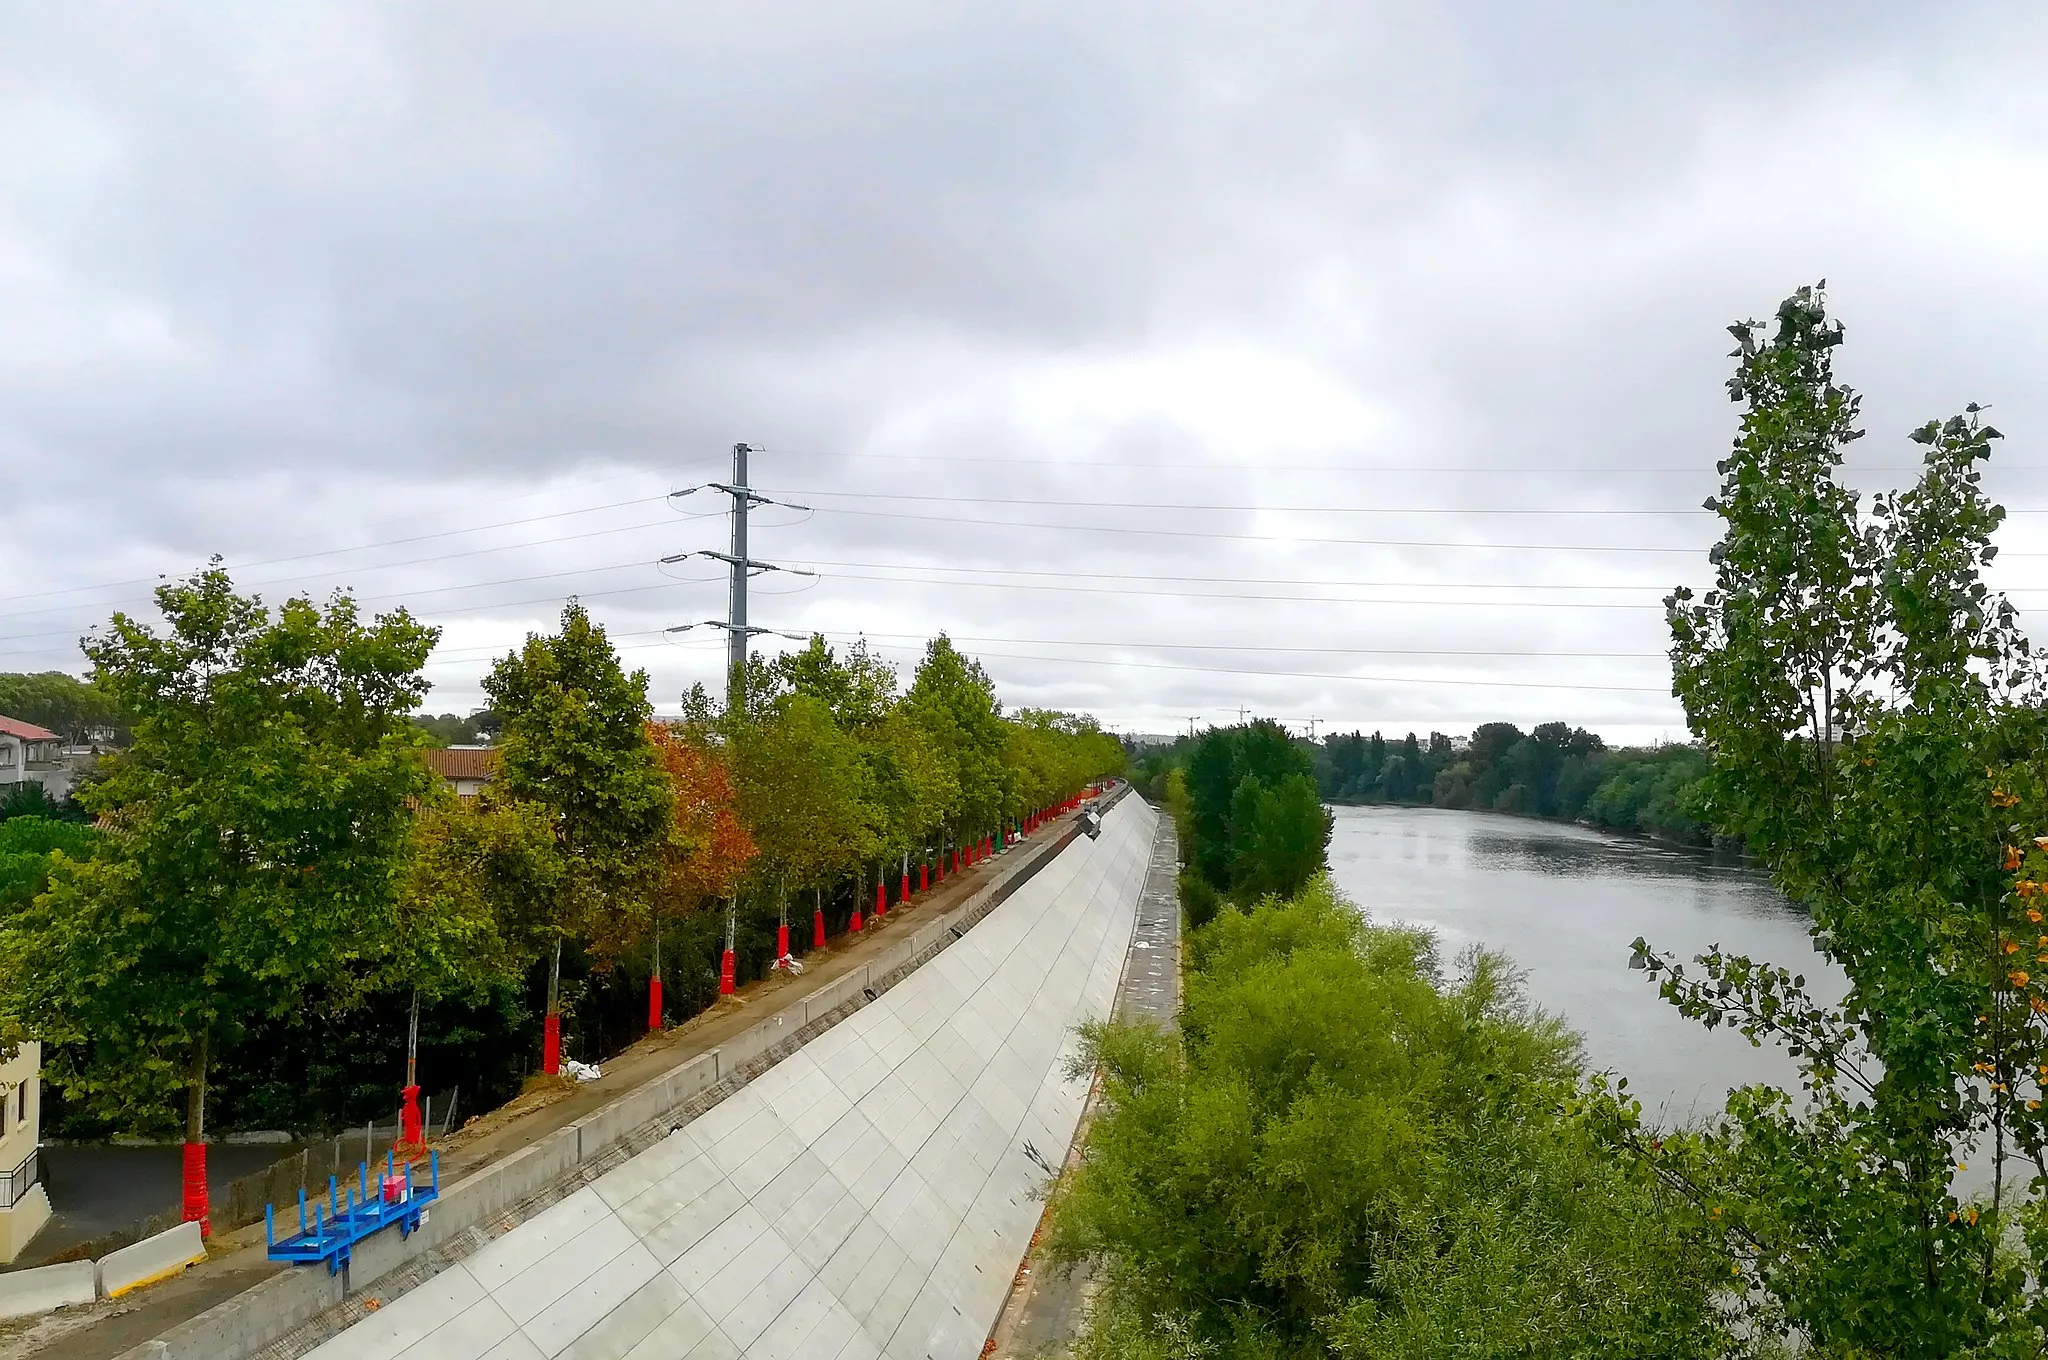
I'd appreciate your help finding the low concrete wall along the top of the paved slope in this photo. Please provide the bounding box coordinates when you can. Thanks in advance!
[119,789,1124,1360]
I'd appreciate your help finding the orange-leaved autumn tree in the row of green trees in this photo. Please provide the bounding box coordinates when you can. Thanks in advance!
[647,723,758,1030]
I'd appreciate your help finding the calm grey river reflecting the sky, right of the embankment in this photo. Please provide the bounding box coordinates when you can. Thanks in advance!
[1329,807,1845,1124]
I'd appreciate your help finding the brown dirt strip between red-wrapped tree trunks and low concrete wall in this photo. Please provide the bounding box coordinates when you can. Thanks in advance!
[0,813,1075,1360]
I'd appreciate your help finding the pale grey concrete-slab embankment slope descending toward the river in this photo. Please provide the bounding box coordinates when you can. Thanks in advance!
[311,799,1155,1360]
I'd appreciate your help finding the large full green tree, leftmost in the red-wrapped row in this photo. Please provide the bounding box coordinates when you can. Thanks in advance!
[0,565,436,1219]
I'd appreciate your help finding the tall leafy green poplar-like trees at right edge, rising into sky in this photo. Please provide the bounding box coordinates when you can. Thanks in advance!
[1612,289,2048,1358]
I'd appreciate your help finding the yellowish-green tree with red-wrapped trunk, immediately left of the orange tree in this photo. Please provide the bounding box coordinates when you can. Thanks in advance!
[483,600,674,1071]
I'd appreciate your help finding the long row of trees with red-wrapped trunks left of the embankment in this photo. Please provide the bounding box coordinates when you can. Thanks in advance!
[0,567,1122,1228]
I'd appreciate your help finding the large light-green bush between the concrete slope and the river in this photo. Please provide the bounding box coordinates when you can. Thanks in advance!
[1049,877,1735,1360]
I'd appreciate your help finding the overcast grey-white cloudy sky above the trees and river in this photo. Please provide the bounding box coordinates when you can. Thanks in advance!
[0,0,2048,739]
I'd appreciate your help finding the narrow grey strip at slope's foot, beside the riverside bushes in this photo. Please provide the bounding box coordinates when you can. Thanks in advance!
[981,811,1180,1360]
